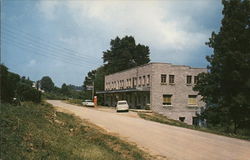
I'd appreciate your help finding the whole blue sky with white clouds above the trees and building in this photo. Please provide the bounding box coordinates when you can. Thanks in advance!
[1,0,223,87]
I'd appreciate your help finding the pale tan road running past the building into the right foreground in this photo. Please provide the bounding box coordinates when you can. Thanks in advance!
[48,100,250,160]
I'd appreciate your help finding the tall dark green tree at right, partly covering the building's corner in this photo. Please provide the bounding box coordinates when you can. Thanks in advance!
[194,0,250,133]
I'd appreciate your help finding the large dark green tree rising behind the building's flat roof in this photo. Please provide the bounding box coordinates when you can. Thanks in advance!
[103,36,150,74]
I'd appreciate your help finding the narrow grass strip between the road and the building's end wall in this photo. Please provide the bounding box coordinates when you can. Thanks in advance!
[137,112,250,140]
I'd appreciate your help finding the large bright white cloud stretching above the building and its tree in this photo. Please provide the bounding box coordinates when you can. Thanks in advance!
[37,0,221,65]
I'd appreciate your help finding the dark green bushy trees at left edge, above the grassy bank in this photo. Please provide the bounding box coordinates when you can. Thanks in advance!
[0,64,41,103]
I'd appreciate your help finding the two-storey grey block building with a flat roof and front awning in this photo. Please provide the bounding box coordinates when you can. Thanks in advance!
[98,63,207,125]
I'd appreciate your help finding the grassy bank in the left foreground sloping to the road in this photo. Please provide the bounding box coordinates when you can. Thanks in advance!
[0,102,152,160]
